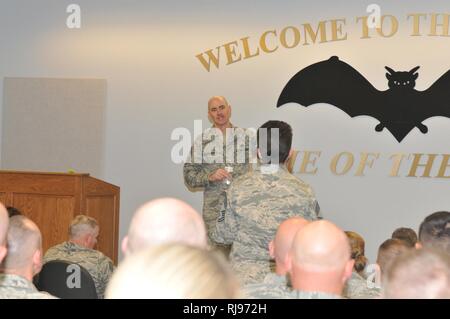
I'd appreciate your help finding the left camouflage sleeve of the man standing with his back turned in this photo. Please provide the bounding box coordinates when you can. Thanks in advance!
[212,192,238,245]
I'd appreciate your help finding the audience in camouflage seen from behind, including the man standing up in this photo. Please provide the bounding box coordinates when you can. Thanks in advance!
[0,121,450,299]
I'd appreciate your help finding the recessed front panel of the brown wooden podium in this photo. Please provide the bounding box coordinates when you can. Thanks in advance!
[13,194,75,252]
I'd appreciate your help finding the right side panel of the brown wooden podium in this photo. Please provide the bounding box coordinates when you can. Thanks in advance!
[86,195,118,262]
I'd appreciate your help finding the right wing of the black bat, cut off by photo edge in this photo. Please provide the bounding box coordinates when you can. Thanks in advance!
[415,70,450,122]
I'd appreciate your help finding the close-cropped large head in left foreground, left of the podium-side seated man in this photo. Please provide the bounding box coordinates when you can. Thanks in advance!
[2,216,42,272]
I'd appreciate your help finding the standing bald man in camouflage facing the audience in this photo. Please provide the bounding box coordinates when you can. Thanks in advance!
[183,96,250,255]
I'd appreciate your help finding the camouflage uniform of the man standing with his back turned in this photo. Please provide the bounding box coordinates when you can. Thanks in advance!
[213,166,321,285]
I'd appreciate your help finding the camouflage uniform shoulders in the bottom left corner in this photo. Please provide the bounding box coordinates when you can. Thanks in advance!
[0,274,57,299]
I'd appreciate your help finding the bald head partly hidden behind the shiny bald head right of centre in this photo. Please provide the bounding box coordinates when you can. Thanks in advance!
[269,217,309,275]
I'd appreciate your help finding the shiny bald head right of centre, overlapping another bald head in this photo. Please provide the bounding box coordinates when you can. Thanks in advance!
[291,221,351,271]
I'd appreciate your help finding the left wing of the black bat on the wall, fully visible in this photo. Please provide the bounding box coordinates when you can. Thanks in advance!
[277,56,385,121]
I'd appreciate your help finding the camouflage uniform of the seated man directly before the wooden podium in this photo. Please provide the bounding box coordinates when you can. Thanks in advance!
[44,242,114,298]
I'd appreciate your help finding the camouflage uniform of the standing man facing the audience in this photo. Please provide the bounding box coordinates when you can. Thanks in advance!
[183,126,251,243]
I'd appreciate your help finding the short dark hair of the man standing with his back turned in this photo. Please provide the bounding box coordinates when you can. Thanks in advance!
[257,121,292,164]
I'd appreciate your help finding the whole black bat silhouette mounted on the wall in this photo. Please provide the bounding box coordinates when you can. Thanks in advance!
[277,56,450,142]
